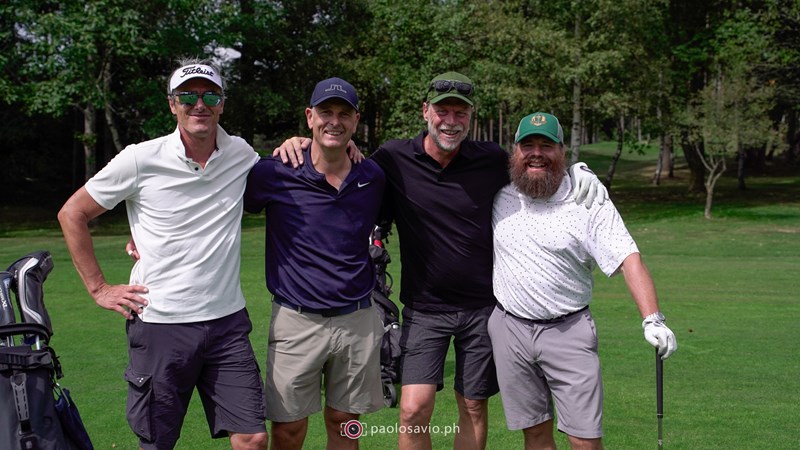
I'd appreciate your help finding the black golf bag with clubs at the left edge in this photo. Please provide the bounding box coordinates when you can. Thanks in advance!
[0,251,93,450]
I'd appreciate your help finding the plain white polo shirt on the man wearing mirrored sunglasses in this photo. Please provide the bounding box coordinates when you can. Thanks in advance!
[86,126,259,323]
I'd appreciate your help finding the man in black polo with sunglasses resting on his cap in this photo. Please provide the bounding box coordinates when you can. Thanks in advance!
[275,72,606,449]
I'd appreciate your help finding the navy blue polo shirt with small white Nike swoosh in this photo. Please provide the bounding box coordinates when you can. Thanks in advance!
[244,150,386,309]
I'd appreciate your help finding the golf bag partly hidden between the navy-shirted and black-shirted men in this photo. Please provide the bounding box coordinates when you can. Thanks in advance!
[369,227,400,408]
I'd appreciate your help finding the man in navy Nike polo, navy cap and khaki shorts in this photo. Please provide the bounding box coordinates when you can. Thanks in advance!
[244,78,385,449]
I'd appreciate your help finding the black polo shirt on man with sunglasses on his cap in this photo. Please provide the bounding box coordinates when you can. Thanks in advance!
[370,132,509,311]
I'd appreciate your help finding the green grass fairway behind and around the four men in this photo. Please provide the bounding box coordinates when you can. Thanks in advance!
[0,145,800,450]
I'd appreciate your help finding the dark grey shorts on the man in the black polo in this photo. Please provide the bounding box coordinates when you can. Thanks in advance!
[400,306,498,400]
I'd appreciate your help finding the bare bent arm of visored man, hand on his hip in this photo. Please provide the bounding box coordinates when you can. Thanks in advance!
[58,187,147,319]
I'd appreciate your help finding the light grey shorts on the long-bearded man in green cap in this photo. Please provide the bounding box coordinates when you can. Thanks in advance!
[489,309,603,439]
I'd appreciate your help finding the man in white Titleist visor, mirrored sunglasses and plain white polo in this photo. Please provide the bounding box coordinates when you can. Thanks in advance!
[58,60,268,450]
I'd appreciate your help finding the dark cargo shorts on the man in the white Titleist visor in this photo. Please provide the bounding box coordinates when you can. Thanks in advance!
[125,309,266,449]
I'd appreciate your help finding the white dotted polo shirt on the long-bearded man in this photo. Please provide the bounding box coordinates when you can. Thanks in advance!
[492,176,639,319]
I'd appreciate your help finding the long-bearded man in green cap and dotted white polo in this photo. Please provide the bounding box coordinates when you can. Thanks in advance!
[489,112,677,449]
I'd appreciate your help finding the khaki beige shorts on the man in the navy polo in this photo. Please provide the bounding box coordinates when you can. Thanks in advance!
[265,302,384,422]
